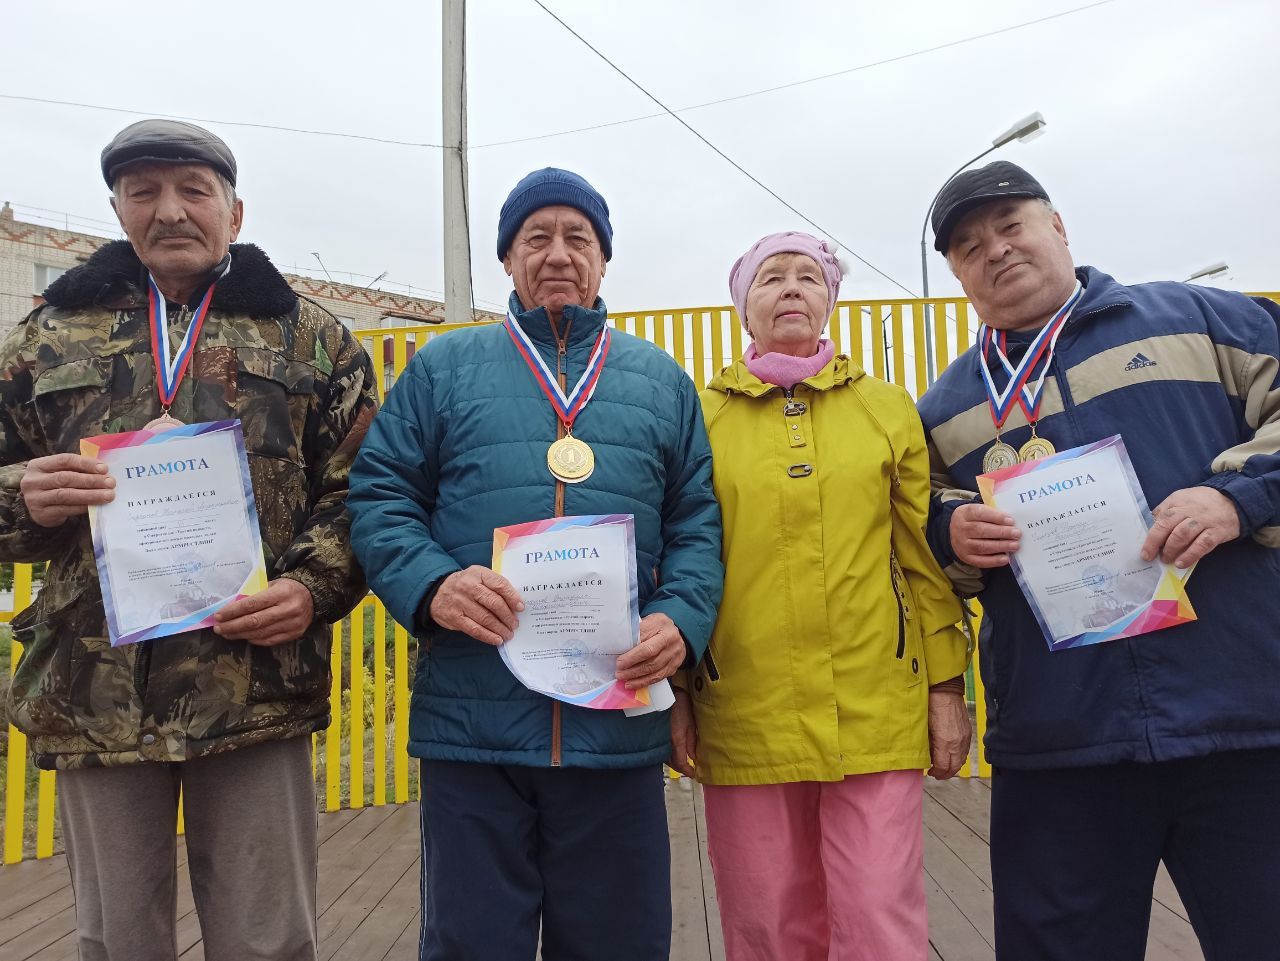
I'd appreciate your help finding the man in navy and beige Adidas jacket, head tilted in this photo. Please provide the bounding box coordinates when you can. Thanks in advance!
[920,161,1280,961]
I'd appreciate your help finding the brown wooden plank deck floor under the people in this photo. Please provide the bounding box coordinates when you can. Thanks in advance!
[0,779,1203,961]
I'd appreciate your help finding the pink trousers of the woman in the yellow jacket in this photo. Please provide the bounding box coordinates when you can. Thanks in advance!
[705,770,929,961]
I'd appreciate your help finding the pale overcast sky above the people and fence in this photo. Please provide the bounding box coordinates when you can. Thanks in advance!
[0,0,1280,310]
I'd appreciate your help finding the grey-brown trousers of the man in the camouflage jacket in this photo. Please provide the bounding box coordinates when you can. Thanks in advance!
[58,737,316,961]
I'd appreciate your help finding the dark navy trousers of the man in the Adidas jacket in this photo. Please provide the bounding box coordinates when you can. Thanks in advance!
[991,752,1280,961]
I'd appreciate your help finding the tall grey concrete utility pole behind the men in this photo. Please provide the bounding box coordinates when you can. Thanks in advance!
[440,0,475,324]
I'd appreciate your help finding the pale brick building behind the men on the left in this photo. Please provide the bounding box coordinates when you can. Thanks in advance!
[0,203,499,333]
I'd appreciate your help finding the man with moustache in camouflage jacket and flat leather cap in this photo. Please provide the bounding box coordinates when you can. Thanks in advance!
[0,120,376,961]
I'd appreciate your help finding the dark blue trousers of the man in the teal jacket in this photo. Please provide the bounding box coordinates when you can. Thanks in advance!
[419,760,671,961]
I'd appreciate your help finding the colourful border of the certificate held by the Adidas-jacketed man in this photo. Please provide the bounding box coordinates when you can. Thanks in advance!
[978,434,1196,651]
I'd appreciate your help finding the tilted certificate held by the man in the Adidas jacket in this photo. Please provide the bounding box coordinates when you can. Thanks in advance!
[978,435,1196,650]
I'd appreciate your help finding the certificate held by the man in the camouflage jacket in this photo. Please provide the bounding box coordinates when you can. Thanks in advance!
[81,420,266,646]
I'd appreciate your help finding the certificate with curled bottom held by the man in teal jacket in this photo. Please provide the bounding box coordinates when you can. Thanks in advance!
[493,514,669,714]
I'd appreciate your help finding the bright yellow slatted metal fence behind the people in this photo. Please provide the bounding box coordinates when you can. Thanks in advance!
[0,293,1280,864]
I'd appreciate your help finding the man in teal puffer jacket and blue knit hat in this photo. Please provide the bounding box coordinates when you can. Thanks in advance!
[347,168,723,961]
